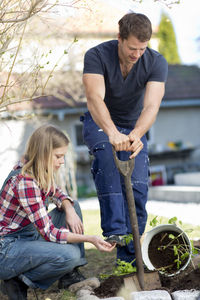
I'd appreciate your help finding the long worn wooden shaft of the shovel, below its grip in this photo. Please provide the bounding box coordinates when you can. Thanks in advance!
[124,176,144,290]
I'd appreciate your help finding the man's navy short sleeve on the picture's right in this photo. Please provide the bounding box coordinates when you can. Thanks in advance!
[148,55,168,82]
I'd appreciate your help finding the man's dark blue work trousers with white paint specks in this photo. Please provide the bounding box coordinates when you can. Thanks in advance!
[81,112,149,262]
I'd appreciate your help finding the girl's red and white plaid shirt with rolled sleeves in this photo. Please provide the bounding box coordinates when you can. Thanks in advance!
[0,163,72,243]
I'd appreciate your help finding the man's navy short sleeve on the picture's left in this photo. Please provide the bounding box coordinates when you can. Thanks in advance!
[83,48,104,75]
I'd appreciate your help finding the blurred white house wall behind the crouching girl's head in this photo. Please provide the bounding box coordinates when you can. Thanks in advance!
[0,115,93,193]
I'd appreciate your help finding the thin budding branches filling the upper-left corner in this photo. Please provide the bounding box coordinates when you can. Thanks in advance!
[0,0,81,112]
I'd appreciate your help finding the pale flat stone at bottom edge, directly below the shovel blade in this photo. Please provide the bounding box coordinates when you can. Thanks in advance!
[130,290,172,300]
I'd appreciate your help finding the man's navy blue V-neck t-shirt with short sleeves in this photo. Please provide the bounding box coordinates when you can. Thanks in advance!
[83,40,168,128]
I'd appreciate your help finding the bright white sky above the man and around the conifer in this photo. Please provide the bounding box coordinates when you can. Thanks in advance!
[102,0,200,66]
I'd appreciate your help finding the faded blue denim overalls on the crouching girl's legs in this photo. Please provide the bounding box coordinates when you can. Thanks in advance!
[0,201,87,289]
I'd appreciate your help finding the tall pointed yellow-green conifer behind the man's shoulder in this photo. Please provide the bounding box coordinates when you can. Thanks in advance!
[158,13,181,64]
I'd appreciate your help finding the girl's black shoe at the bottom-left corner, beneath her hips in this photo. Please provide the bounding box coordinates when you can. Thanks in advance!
[0,277,28,300]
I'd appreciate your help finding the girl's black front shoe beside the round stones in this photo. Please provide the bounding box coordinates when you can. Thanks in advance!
[58,268,86,289]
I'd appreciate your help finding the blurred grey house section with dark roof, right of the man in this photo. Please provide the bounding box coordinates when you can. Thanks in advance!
[149,65,200,185]
